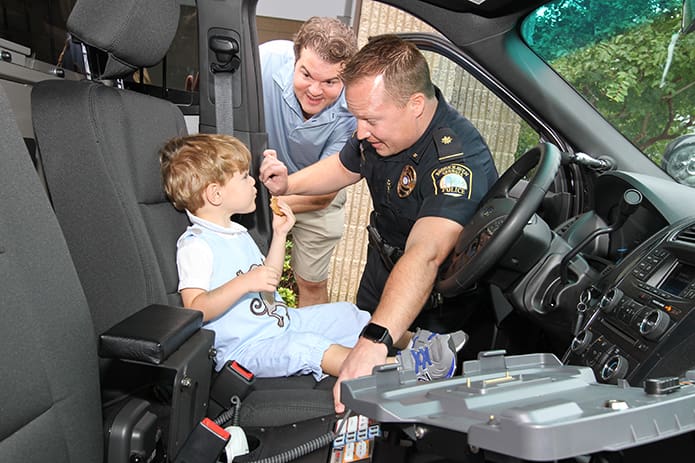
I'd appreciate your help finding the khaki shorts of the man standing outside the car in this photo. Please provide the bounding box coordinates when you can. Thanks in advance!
[291,190,347,282]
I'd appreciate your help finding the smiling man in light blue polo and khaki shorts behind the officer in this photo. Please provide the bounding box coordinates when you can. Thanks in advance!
[259,17,357,306]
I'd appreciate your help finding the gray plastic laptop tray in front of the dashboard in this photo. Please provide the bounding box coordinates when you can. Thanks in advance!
[341,351,695,461]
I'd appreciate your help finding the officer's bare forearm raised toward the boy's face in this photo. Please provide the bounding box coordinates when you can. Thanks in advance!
[286,153,361,195]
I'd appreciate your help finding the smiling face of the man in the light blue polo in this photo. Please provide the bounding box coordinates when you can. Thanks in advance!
[293,48,343,119]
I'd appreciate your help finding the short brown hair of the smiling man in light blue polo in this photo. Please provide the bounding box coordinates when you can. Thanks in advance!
[294,16,357,64]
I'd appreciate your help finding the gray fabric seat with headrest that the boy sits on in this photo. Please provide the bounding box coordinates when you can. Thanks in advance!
[32,0,332,426]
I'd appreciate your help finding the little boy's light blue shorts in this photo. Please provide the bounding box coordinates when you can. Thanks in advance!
[235,302,371,381]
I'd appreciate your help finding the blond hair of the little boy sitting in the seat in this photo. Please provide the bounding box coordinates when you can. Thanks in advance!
[159,134,251,213]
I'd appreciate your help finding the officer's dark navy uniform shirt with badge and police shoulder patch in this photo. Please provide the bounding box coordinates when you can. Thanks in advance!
[340,89,497,249]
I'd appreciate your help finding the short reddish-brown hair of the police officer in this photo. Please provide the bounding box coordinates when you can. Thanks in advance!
[340,34,434,105]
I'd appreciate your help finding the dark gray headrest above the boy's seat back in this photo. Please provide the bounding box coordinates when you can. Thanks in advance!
[67,0,180,79]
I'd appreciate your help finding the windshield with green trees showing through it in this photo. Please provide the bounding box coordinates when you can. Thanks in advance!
[522,0,695,186]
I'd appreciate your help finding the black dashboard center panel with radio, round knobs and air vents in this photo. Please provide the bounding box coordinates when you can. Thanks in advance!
[568,219,695,385]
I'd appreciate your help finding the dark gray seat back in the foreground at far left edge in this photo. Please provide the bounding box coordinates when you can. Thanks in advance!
[0,85,103,463]
